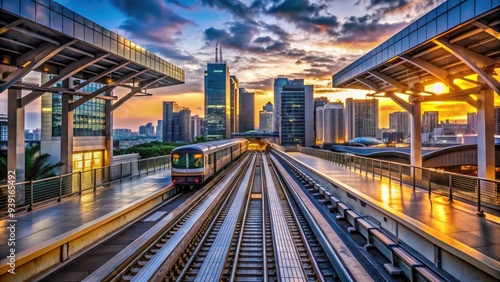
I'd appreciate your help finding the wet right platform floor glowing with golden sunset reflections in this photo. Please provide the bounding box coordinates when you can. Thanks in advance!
[287,152,500,261]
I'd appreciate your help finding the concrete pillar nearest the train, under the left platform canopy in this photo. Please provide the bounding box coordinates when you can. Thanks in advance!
[61,94,73,174]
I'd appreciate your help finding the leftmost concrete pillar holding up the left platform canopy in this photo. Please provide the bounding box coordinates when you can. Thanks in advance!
[7,89,25,183]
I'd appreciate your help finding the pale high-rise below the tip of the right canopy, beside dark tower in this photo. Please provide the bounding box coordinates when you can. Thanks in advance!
[323,102,346,143]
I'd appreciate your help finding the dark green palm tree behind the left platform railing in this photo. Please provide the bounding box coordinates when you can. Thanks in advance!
[0,144,63,181]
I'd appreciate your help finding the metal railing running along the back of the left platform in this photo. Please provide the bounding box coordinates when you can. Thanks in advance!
[0,155,170,218]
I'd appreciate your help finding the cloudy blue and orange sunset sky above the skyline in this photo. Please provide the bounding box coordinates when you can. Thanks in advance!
[0,0,499,131]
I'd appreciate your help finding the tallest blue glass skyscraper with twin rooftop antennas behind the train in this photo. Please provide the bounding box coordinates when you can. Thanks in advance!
[205,47,231,140]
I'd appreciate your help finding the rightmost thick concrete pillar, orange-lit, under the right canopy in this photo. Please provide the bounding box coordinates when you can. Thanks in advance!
[477,89,495,179]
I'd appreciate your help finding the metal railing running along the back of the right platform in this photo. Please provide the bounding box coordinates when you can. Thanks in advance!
[273,144,500,215]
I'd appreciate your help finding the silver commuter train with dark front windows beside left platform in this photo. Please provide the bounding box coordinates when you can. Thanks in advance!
[171,139,248,186]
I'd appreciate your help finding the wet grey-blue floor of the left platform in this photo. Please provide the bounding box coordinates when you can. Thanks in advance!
[0,169,171,258]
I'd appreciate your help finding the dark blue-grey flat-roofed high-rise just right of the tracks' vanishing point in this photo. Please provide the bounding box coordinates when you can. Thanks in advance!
[275,79,314,146]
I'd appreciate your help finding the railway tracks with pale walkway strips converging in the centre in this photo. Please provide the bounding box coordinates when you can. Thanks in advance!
[54,153,360,281]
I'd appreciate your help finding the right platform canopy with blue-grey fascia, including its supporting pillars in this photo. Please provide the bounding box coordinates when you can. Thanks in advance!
[332,0,500,179]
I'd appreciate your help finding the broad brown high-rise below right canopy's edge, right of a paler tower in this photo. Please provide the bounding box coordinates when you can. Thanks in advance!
[346,98,378,140]
